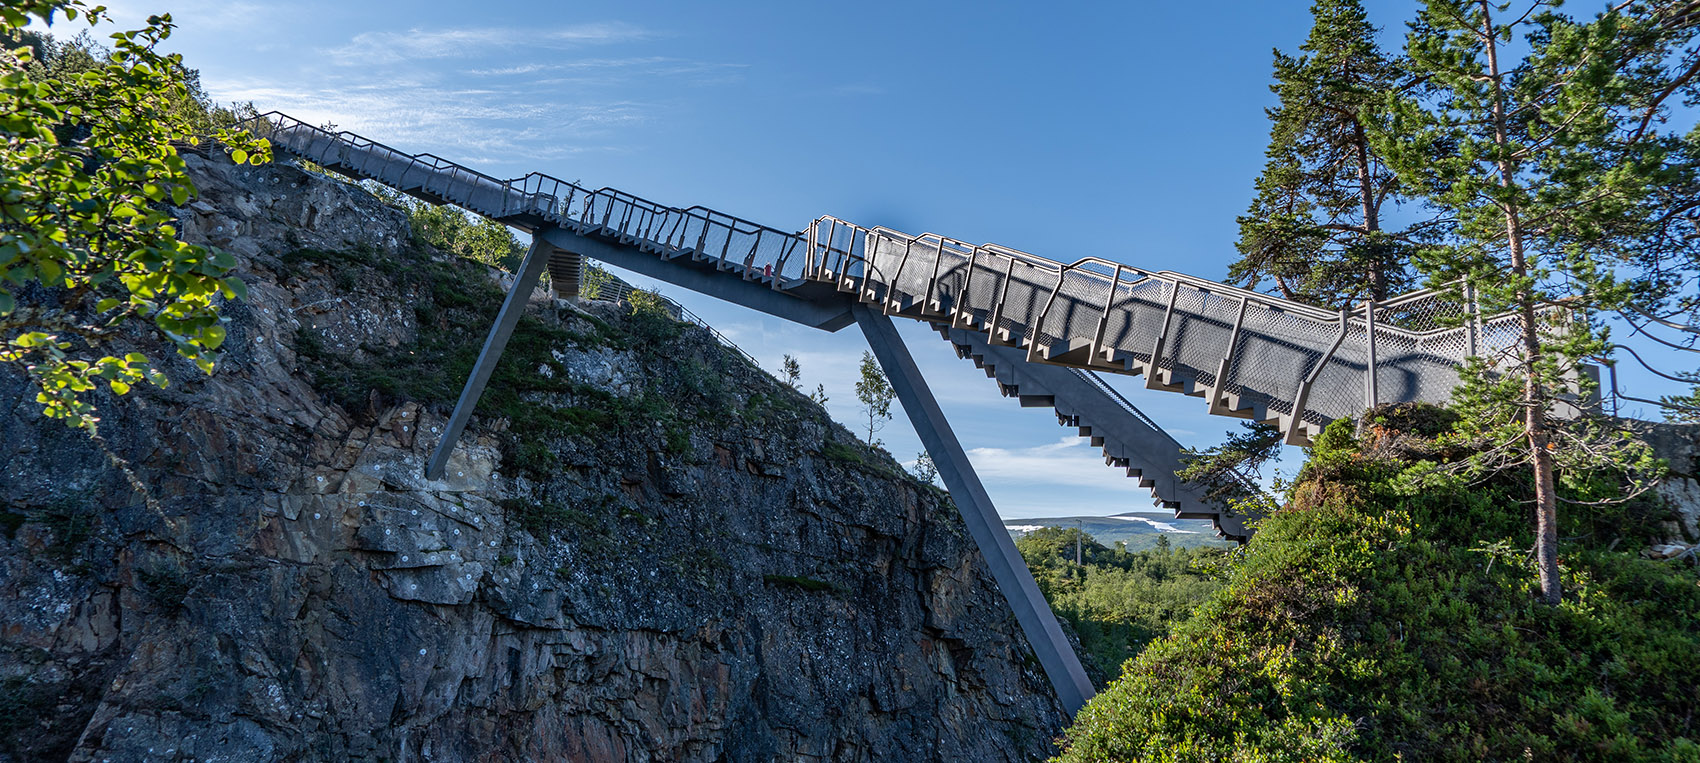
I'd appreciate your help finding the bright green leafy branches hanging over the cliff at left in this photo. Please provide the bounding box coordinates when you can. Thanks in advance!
[0,0,270,428]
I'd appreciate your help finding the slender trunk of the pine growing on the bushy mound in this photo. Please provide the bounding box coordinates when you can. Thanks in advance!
[1477,0,1564,605]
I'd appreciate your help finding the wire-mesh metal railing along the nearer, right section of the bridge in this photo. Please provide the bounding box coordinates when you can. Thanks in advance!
[808,218,1562,440]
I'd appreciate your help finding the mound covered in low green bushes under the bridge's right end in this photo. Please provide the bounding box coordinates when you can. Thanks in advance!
[1057,408,1700,761]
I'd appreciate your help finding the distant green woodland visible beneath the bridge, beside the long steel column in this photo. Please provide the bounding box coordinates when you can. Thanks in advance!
[1015,527,1226,688]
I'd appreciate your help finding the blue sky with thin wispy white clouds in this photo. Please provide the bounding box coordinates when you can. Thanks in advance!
[62,0,1686,517]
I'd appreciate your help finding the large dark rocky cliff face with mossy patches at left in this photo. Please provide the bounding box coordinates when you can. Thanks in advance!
[0,156,1063,761]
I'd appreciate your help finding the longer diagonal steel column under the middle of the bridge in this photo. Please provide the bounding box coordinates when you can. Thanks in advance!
[850,302,1095,715]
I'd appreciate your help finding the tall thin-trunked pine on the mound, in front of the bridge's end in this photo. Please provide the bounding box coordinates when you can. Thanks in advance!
[1372,0,1693,603]
